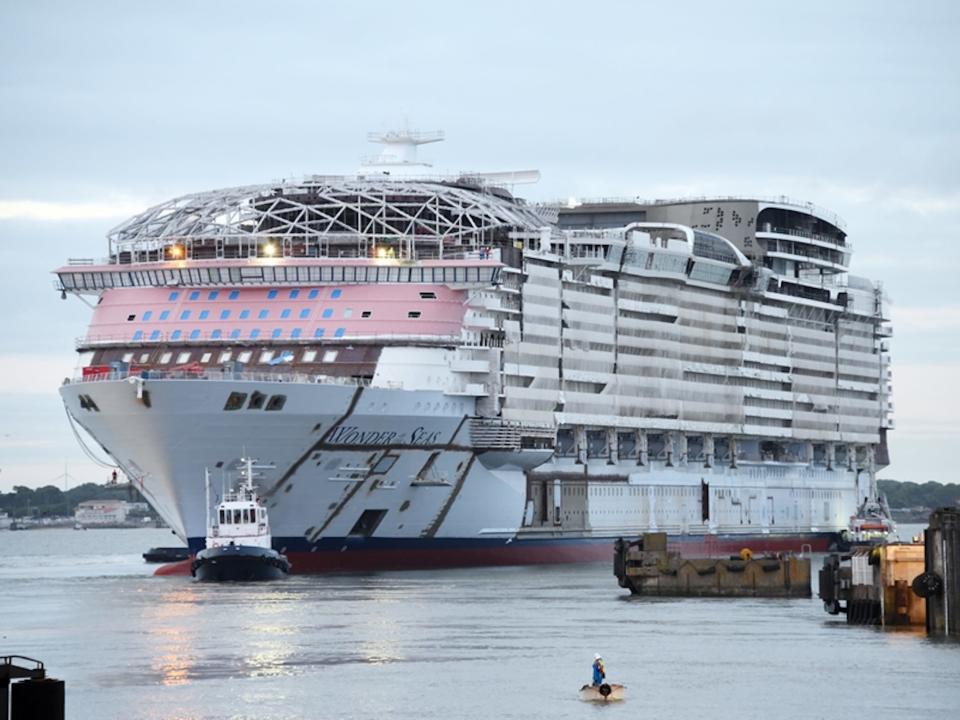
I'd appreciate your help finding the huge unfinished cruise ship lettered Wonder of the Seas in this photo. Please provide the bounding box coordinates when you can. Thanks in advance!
[55,131,893,572]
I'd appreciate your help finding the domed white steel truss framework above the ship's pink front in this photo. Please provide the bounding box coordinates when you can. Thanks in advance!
[108,177,550,262]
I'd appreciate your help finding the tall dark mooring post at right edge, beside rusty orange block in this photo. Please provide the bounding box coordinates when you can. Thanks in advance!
[914,508,960,637]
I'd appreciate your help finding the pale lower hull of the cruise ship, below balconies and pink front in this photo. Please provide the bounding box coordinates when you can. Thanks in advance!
[61,378,856,573]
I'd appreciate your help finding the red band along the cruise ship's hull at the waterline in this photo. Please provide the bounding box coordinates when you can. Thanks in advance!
[154,534,834,575]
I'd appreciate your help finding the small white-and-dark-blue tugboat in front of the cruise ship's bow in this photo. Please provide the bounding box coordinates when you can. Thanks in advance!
[190,458,290,582]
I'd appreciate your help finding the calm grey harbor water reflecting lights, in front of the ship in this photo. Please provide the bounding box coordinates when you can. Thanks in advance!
[0,529,960,720]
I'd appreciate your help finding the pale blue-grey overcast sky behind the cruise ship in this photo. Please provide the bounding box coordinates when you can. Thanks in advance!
[0,0,960,490]
